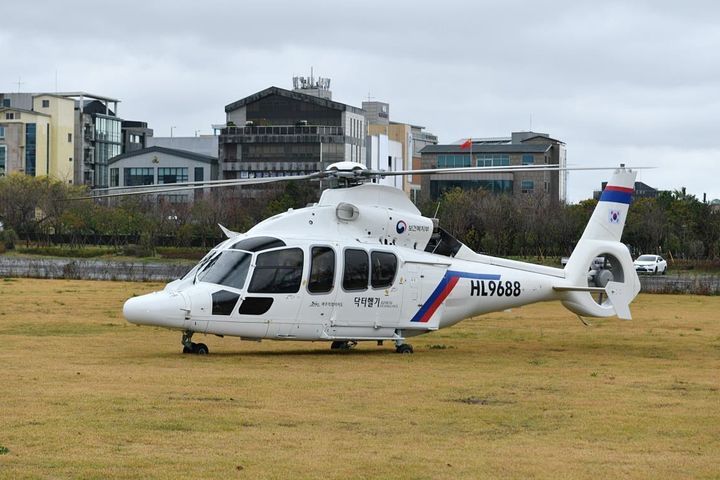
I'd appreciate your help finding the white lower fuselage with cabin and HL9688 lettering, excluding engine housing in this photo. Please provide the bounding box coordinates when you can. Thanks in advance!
[125,235,557,341]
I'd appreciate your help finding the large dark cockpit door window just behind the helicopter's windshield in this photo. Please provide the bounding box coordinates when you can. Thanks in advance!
[248,248,303,293]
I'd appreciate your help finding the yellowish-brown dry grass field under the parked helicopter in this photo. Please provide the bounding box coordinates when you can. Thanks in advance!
[0,279,720,479]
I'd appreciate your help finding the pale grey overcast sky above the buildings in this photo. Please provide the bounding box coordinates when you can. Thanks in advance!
[0,0,720,202]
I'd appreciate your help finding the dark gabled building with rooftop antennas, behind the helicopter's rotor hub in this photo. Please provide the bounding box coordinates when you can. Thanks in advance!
[218,83,367,179]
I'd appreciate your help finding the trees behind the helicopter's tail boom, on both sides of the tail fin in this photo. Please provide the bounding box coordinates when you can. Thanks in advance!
[422,189,720,260]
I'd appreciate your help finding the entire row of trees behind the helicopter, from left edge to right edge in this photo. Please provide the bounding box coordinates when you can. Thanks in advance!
[0,174,720,259]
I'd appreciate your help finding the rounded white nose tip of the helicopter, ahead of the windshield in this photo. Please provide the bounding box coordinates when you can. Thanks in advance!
[123,291,189,328]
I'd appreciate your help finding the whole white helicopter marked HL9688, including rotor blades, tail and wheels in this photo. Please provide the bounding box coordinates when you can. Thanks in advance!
[118,162,640,354]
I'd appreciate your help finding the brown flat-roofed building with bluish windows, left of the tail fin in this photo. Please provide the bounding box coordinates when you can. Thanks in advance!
[421,132,566,201]
